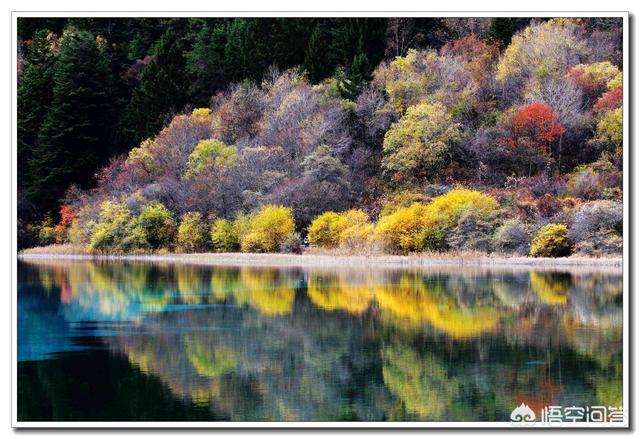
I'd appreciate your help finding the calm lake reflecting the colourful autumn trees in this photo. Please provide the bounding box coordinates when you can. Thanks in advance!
[17,259,623,421]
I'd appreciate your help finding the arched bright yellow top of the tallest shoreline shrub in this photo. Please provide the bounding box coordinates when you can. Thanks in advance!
[427,188,498,226]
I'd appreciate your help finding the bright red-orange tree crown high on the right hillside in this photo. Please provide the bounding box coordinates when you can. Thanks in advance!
[499,102,565,150]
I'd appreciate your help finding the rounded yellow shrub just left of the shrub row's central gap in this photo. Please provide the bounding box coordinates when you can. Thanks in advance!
[241,205,296,252]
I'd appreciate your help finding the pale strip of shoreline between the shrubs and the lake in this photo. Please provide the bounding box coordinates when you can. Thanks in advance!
[18,252,623,270]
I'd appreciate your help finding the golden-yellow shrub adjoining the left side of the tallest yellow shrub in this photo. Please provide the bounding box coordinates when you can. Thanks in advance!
[374,203,438,253]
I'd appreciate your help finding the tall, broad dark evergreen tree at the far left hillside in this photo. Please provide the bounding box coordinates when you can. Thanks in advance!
[29,30,112,211]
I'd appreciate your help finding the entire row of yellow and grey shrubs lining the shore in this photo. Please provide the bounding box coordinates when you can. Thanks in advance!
[48,188,623,257]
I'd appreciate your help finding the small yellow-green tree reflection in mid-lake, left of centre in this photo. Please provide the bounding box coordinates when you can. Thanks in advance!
[185,337,238,378]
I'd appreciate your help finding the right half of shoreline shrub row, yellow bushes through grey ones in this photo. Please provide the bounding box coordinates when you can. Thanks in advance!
[308,188,623,257]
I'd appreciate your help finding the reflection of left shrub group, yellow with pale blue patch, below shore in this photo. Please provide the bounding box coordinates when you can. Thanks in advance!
[26,262,302,320]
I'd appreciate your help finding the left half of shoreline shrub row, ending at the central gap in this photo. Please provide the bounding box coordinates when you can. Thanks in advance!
[58,201,301,253]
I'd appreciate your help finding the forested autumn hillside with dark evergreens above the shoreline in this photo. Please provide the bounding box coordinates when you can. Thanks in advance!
[17,18,623,256]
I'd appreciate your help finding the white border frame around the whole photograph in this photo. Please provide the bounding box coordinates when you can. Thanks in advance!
[11,11,632,431]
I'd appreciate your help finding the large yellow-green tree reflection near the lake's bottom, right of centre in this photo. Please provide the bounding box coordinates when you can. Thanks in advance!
[382,346,458,420]
